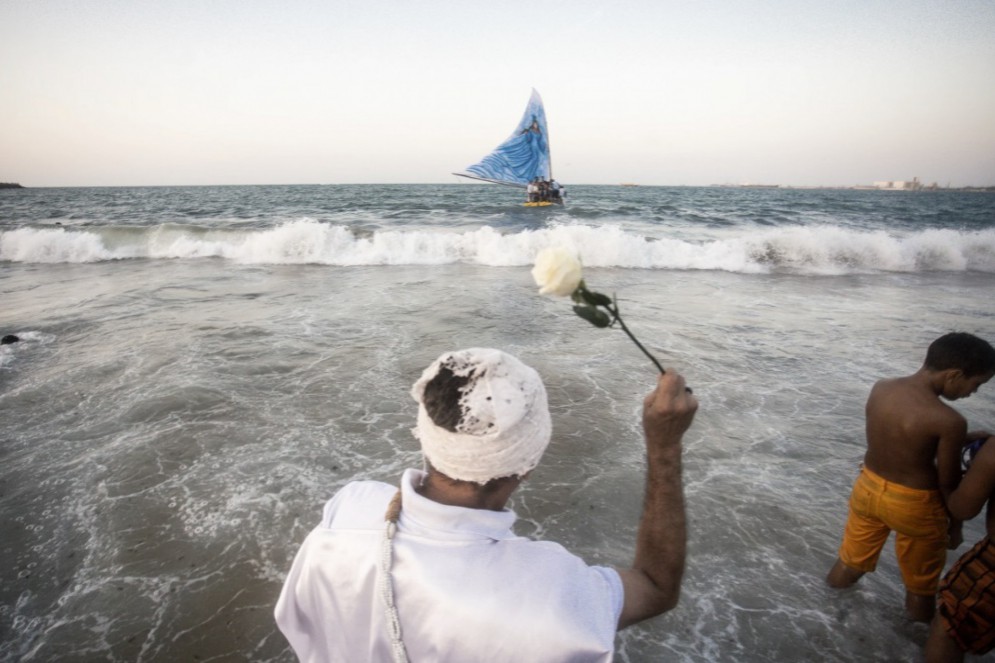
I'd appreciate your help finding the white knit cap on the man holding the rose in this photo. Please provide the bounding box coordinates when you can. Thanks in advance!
[411,348,552,484]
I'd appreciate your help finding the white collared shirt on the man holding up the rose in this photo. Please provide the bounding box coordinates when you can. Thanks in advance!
[275,470,623,663]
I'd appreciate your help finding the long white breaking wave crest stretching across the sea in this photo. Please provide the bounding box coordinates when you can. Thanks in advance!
[0,219,995,274]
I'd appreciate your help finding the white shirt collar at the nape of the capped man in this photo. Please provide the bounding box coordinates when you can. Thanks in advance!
[398,469,517,541]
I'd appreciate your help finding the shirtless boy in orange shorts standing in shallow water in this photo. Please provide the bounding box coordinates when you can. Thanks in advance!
[826,333,995,622]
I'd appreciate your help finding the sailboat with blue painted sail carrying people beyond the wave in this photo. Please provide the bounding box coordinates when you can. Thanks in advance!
[453,89,566,207]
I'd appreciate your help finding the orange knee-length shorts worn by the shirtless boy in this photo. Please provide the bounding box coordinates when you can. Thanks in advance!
[839,467,948,596]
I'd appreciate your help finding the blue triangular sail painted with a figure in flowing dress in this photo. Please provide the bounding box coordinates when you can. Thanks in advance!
[457,90,552,186]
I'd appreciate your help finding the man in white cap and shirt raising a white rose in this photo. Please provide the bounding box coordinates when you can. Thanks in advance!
[275,348,698,663]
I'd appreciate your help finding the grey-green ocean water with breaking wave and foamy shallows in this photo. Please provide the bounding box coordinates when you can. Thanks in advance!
[0,184,995,663]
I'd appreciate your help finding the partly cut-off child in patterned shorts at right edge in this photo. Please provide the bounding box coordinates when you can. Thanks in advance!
[926,437,995,663]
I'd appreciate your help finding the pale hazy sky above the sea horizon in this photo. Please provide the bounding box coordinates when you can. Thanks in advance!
[0,0,995,187]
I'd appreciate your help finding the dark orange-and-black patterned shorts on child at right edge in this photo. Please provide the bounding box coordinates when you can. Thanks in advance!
[938,536,995,654]
